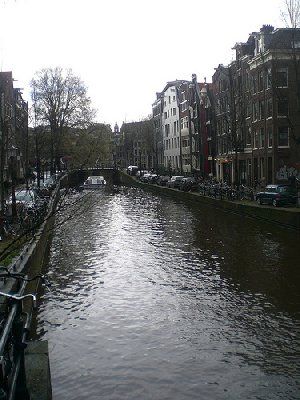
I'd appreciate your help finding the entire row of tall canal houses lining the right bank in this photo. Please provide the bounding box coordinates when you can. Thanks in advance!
[115,25,300,186]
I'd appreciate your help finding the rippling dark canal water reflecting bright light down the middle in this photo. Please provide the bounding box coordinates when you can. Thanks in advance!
[37,187,300,400]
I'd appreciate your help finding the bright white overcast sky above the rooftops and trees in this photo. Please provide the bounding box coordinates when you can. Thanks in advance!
[0,0,283,125]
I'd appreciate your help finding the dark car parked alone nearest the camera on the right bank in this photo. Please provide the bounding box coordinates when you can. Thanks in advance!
[255,185,297,207]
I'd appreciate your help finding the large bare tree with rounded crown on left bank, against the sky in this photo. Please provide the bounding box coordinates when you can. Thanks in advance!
[31,67,95,172]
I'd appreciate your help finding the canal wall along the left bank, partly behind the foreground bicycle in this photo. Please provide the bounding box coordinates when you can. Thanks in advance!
[0,177,63,400]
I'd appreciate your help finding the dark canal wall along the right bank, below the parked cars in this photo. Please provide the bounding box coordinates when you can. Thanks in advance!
[120,172,300,232]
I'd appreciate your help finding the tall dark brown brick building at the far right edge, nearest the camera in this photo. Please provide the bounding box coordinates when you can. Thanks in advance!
[249,28,300,183]
